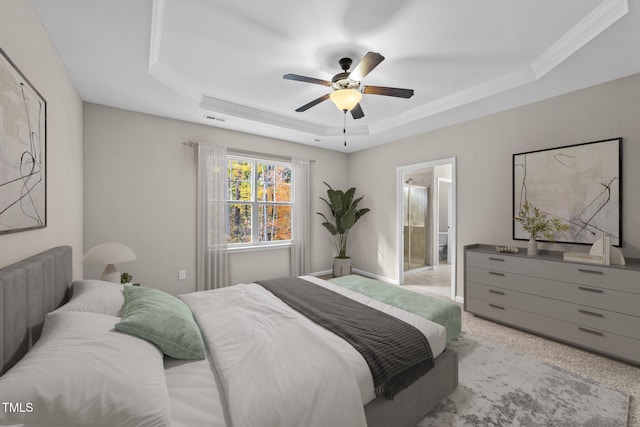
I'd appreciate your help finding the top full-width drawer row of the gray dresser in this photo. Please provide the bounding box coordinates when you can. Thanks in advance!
[466,251,640,295]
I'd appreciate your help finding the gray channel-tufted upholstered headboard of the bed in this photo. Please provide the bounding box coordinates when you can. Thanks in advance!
[0,246,72,375]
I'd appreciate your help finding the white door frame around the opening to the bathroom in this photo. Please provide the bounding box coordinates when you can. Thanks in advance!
[396,157,458,300]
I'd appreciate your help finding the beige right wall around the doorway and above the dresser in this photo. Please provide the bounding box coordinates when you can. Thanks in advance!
[348,75,640,295]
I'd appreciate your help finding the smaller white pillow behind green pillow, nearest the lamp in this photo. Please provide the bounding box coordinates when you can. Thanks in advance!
[56,280,124,316]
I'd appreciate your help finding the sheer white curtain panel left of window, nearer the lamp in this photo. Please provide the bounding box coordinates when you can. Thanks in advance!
[196,144,229,291]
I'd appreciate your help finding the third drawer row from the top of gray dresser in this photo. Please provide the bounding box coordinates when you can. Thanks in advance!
[465,284,640,344]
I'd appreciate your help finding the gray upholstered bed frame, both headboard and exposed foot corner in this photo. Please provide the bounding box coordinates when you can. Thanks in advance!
[0,246,458,427]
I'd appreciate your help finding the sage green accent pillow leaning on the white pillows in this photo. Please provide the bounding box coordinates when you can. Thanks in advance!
[115,286,205,360]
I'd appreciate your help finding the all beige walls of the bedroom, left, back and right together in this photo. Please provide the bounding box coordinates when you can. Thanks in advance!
[5,0,640,300]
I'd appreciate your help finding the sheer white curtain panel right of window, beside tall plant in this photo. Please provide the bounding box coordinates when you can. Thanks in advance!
[291,159,311,276]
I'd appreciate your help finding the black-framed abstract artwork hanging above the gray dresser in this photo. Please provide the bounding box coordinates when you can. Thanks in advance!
[512,138,622,246]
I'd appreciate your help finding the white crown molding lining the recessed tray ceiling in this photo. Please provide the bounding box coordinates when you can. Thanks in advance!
[149,0,629,144]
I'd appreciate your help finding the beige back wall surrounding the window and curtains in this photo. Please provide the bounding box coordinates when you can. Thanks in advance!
[84,103,347,294]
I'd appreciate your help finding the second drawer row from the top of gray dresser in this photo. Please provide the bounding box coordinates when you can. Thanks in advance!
[466,267,640,316]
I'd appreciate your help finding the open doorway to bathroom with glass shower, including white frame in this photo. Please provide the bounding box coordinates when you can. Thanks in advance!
[397,158,456,299]
